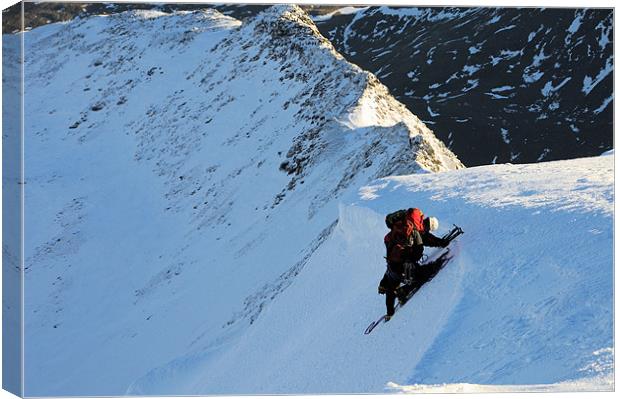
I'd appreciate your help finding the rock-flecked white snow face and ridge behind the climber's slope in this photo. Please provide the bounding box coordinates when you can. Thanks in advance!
[12,6,462,396]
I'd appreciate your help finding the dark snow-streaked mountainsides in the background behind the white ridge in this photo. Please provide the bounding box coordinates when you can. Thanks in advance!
[3,2,614,166]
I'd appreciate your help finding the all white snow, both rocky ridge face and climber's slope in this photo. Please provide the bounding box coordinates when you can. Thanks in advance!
[3,6,614,396]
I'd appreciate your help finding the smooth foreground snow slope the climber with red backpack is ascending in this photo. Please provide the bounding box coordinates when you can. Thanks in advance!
[128,155,614,394]
